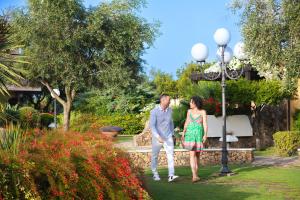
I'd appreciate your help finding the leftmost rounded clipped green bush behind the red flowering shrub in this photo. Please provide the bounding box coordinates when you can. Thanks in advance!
[19,107,40,128]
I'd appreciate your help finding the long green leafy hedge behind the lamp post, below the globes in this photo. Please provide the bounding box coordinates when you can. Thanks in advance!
[177,75,294,114]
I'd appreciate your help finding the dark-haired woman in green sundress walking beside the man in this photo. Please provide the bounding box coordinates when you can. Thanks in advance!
[182,96,207,182]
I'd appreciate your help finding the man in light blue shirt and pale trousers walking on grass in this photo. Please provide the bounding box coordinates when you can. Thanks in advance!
[150,94,178,182]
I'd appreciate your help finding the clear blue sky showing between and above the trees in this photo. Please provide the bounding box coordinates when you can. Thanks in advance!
[0,0,242,77]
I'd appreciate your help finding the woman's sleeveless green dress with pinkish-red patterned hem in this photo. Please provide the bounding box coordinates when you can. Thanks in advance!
[183,113,204,152]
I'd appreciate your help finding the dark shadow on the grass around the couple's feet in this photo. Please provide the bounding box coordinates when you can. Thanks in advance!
[145,166,258,200]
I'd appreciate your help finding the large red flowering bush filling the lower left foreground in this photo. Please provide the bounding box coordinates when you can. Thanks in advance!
[0,131,148,199]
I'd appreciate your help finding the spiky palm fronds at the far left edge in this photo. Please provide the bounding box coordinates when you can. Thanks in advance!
[0,15,27,95]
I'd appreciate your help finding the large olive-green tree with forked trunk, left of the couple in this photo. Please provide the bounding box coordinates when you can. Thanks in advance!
[12,0,157,131]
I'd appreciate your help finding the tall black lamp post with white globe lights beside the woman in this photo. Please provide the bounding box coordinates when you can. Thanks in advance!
[191,28,246,175]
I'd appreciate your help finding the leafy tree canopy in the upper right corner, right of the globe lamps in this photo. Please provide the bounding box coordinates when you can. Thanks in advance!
[232,0,300,91]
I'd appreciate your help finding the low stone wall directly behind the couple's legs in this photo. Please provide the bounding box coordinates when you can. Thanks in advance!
[128,148,254,168]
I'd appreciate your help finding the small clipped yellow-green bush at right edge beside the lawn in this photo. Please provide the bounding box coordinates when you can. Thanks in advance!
[273,131,300,156]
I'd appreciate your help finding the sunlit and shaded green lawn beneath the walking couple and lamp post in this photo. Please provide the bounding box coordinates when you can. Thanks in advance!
[146,165,300,200]
